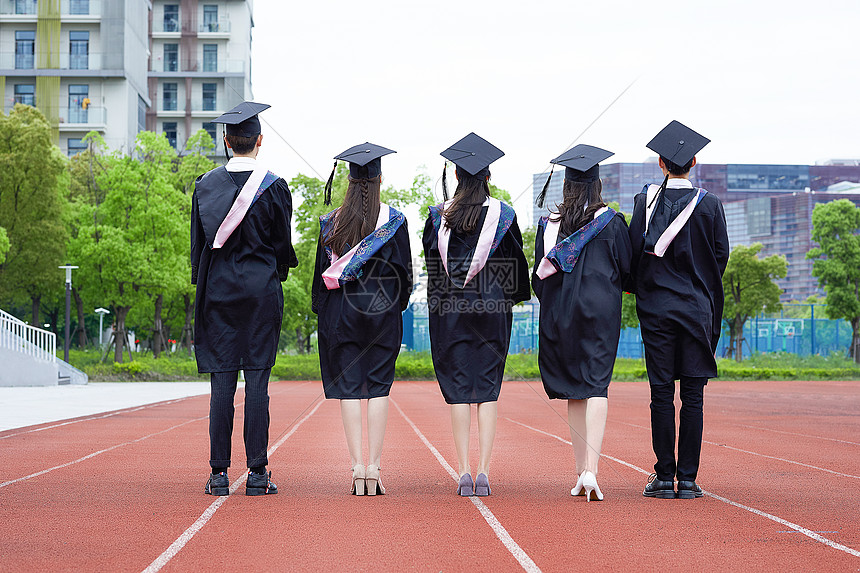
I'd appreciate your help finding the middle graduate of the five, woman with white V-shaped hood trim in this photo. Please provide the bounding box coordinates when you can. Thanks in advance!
[423,133,530,495]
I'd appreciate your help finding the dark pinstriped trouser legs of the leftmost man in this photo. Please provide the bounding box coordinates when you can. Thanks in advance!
[209,368,272,468]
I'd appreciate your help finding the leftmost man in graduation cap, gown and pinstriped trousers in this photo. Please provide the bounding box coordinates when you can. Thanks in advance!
[191,102,298,495]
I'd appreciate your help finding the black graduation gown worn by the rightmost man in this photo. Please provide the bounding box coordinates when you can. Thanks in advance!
[630,183,729,384]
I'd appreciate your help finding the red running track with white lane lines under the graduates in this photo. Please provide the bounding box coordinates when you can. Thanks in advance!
[0,381,860,571]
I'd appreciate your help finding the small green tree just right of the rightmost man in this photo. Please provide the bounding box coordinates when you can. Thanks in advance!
[723,243,788,362]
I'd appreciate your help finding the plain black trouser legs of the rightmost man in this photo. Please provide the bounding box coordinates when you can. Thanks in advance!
[651,376,708,481]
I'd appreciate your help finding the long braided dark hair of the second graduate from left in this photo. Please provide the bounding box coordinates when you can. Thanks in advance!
[324,175,382,255]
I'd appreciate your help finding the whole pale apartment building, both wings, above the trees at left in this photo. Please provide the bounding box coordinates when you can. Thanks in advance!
[0,0,253,155]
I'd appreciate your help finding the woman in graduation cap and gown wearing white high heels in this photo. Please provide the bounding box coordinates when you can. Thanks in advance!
[532,145,631,501]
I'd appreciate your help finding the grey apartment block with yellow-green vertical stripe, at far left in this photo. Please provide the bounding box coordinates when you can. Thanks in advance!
[0,0,151,154]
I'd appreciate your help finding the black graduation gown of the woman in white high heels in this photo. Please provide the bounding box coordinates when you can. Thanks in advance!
[532,213,631,400]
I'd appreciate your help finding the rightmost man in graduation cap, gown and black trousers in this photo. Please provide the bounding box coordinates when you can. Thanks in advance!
[630,121,729,499]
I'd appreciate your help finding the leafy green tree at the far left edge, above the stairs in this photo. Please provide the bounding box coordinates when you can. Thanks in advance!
[0,104,68,324]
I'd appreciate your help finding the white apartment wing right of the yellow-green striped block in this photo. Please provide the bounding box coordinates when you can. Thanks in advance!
[146,0,253,149]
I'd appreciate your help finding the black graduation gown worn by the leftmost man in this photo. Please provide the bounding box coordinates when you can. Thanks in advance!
[191,167,298,372]
